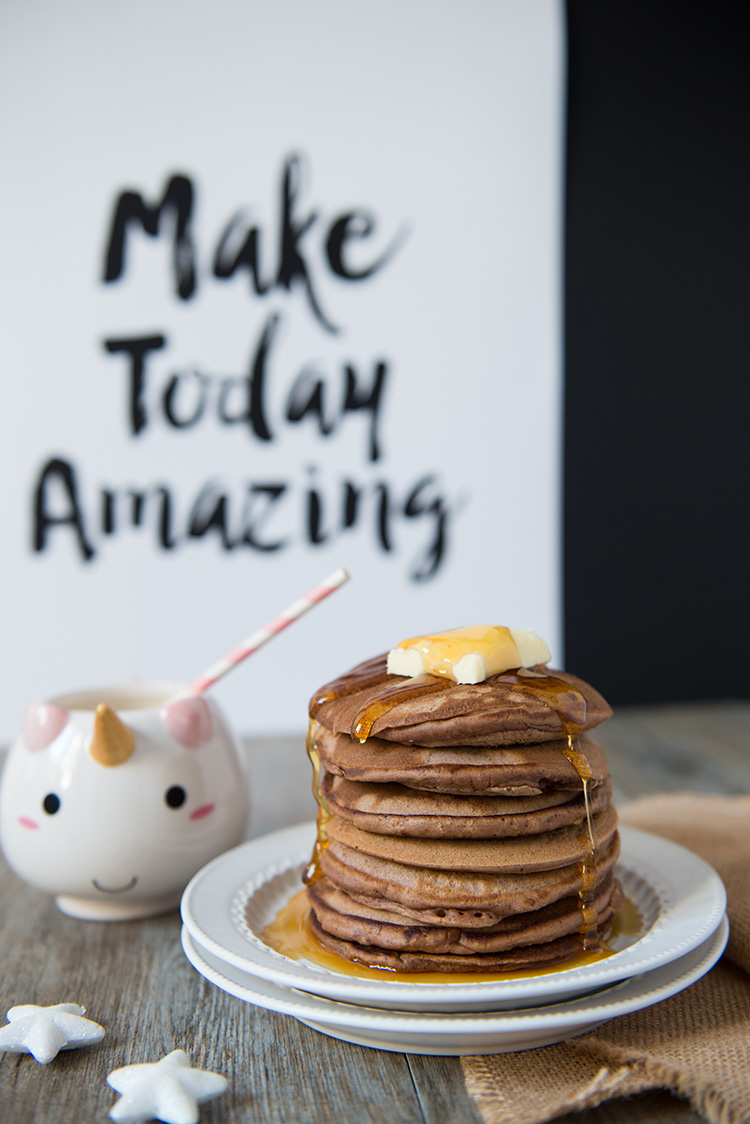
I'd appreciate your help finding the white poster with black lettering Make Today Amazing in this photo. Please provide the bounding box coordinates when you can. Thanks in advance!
[0,0,564,740]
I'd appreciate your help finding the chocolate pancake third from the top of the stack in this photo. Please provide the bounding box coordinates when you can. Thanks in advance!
[322,773,612,839]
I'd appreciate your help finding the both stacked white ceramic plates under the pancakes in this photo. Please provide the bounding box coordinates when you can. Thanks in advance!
[182,823,729,1054]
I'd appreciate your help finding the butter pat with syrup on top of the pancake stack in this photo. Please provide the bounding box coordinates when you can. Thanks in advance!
[388,625,550,683]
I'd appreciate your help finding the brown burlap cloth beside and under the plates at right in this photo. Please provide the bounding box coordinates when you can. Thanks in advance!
[462,795,750,1124]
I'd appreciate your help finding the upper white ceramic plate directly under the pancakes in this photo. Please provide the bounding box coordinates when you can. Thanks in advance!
[182,823,726,1012]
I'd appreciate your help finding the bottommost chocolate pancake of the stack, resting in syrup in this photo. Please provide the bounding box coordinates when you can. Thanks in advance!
[309,912,612,975]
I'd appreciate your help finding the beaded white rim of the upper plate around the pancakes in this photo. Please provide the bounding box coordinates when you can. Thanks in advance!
[181,821,726,1007]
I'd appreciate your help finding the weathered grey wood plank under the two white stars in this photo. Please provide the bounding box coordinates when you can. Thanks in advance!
[0,868,424,1124]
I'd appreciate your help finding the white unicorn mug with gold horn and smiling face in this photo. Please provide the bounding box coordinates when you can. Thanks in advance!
[0,683,249,921]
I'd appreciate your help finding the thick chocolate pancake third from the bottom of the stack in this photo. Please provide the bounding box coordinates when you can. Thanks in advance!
[320,832,620,919]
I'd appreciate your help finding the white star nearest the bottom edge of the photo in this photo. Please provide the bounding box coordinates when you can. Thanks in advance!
[107,1050,229,1124]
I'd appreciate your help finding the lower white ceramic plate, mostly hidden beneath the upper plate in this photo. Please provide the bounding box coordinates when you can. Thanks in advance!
[182,918,729,1057]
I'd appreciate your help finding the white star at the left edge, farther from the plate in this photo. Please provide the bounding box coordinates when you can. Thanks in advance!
[0,1003,105,1066]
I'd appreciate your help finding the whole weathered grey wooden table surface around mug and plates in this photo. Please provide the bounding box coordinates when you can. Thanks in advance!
[0,703,750,1124]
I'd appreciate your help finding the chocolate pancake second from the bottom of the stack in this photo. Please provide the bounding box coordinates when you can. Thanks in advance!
[309,873,623,955]
